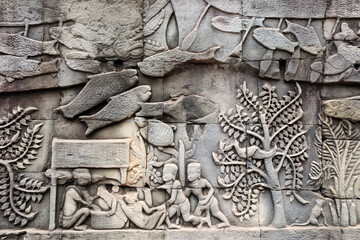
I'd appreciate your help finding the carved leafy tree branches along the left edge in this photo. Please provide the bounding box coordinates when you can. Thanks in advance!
[0,107,47,227]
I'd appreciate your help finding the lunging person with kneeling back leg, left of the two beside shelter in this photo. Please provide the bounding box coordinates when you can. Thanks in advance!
[158,163,208,228]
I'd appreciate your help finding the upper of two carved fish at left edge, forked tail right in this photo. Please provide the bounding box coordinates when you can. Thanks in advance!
[0,33,59,57]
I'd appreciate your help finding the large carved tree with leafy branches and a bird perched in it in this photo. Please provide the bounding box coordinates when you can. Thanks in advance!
[213,82,308,227]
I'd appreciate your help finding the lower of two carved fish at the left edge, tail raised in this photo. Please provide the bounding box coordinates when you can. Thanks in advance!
[0,59,59,82]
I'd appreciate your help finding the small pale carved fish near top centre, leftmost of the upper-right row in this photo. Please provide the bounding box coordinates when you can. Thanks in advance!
[211,16,265,33]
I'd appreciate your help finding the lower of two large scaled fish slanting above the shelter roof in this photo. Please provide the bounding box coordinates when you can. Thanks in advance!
[80,85,151,135]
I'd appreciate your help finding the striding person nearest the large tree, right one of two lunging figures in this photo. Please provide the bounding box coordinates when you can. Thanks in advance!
[185,162,230,228]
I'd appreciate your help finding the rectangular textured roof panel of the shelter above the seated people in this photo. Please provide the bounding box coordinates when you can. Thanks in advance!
[52,138,131,168]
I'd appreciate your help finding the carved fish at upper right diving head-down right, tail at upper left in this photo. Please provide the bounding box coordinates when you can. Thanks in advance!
[283,20,324,55]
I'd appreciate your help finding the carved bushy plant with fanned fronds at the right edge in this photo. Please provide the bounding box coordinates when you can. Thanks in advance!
[315,115,360,226]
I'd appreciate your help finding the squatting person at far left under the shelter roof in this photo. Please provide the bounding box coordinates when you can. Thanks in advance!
[60,168,94,230]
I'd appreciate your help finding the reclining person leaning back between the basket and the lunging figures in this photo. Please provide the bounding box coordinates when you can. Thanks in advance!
[108,186,166,230]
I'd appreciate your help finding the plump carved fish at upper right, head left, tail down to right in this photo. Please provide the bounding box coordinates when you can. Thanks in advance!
[253,27,299,53]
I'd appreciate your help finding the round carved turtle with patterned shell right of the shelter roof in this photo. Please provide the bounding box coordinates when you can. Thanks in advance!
[135,117,174,147]
